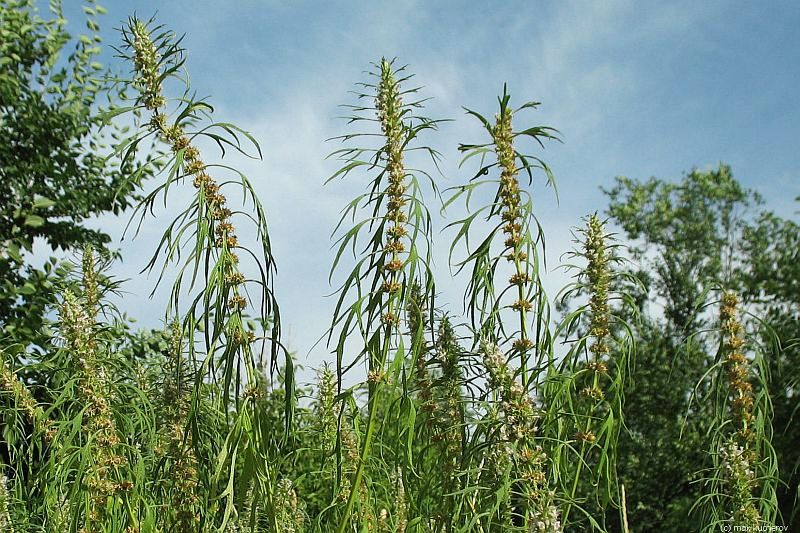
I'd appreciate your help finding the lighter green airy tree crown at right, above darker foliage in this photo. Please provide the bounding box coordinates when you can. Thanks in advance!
[604,165,762,334]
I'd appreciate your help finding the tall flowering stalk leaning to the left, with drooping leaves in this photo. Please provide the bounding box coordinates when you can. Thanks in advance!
[118,18,284,530]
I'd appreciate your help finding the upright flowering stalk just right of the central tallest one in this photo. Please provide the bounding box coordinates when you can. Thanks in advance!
[446,87,560,529]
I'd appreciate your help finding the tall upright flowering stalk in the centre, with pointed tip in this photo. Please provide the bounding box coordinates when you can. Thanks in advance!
[331,59,436,533]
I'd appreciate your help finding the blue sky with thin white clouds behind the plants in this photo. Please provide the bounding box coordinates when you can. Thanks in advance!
[56,0,800,372]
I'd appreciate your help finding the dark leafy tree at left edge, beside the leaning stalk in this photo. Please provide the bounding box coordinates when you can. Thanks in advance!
[0,0,147,358]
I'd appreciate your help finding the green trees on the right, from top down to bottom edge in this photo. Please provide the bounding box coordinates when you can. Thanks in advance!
[604,165,800,531]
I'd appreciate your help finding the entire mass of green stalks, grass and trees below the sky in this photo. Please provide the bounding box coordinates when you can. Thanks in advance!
[0,4,800,533]
